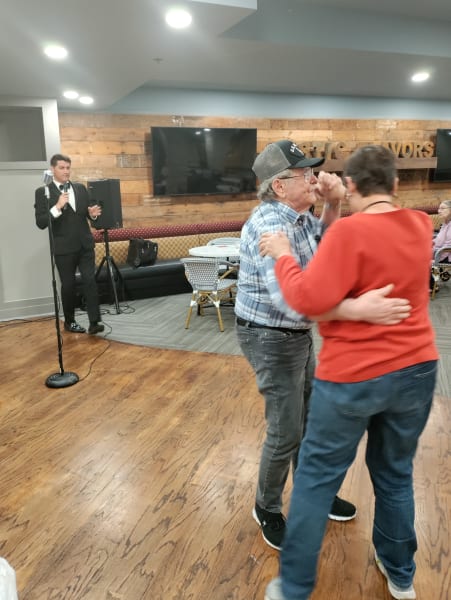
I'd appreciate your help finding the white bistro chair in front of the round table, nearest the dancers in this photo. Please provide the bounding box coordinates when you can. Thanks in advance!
[180,257,236,331]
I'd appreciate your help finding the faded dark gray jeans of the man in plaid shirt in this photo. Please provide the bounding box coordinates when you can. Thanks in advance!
[236,325,314,512]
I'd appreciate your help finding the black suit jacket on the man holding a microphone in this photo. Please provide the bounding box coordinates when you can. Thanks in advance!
[34,182,94,254]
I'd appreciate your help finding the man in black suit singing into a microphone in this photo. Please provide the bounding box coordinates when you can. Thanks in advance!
[34,154,104,333]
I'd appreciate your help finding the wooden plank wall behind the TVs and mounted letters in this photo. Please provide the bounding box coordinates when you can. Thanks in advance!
[59,113,451,227]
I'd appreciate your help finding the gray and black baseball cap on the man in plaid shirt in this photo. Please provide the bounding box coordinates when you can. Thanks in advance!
[252,140,325,182]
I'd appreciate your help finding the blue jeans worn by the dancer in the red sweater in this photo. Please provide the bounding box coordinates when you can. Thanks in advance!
[281,361,437,600]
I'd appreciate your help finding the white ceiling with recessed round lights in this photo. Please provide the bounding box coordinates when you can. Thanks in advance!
[0,0,451,111]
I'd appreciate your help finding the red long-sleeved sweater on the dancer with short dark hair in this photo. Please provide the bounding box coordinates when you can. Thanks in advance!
[275,209,438,383]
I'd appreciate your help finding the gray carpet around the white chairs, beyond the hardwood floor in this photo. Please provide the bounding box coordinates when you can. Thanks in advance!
[77,281,451,397]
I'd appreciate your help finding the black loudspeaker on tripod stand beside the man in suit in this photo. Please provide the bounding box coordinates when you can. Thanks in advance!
[88,179,124,314]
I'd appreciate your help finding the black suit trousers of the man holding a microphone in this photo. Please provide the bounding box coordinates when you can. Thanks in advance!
[55,249,100,323]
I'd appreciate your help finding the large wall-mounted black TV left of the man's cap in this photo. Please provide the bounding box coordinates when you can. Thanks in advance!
[151,127,257,196]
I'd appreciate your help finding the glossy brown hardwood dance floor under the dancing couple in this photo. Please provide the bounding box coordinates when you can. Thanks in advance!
[0,321,451,600]
